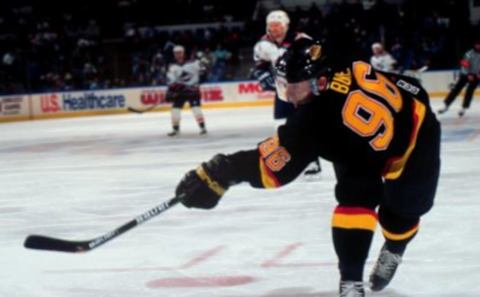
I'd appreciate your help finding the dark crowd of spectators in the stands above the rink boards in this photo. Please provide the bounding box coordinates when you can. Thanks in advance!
[0,0,478,94]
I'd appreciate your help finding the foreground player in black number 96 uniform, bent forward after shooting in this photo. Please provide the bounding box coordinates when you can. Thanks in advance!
[176,39,440,297]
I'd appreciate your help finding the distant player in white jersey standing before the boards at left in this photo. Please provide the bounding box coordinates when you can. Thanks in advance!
[166,45,207,136]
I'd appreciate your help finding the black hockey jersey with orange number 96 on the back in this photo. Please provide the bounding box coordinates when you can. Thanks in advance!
[227,61,436,188]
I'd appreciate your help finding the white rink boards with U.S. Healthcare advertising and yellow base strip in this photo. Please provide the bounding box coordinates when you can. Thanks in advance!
[0,71,480,122]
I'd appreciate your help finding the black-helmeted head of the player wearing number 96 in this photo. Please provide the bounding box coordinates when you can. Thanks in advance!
[275,38,331,104]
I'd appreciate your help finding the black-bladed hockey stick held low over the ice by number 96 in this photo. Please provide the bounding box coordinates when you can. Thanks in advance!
[23,197,181,253]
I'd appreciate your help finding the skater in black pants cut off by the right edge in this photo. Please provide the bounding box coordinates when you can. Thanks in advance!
[438,40,480,117]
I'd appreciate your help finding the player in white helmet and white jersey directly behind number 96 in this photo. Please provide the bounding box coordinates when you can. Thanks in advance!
[253,10,322,175]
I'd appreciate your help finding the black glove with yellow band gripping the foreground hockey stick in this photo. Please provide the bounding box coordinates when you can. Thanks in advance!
[175,154,238,209]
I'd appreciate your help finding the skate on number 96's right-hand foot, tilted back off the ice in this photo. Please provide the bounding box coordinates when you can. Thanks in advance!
[370,245,402,291]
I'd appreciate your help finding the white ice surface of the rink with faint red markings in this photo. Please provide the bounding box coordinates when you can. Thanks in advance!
[0,100,480,297]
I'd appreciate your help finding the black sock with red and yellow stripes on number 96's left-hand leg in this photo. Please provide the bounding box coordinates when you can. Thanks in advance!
[332,206,377,281]
